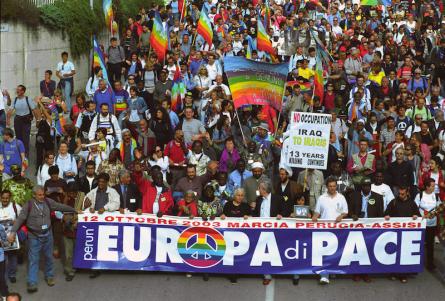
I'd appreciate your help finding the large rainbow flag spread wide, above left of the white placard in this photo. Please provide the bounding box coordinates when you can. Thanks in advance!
[224,56,288,110]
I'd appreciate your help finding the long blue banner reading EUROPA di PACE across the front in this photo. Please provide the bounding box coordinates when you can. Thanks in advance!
[74,212,425,274]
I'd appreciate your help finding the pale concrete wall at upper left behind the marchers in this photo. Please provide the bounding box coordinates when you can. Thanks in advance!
[0,23,97,97]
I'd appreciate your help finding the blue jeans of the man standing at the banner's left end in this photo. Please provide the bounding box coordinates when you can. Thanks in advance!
[28,231,54,285]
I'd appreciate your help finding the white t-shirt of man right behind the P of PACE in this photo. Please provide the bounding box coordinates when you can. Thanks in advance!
[315,192,348,220]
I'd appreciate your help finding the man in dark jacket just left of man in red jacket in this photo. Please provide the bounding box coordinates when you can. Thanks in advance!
[113,170,142,214]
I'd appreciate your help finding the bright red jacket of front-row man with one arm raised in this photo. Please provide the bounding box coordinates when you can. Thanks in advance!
[133,172,174,215]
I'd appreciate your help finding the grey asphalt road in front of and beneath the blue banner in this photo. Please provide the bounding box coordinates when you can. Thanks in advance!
[6,256,445,301]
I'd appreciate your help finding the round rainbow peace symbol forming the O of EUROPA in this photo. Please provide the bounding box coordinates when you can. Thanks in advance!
[177,227,226,269]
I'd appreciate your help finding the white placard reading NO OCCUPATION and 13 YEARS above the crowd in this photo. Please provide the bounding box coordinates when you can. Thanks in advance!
[282,112,331,169]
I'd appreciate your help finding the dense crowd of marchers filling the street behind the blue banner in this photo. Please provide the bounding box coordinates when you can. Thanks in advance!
[0,0,445,296]
